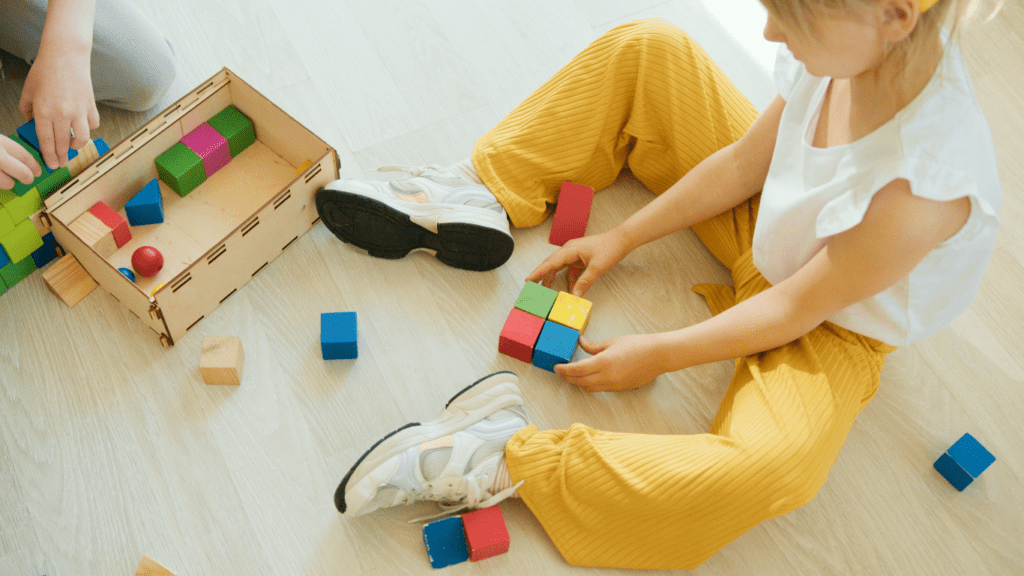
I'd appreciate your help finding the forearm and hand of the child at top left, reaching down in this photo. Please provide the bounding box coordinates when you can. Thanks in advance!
[18,0,99,168]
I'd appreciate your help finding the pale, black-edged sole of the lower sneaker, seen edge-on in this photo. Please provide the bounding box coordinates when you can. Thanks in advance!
[334,371,523,513]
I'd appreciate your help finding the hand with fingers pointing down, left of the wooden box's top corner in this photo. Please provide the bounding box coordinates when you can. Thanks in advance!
[18,37,99,169]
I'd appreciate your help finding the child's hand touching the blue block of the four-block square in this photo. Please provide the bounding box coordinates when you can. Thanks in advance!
[555,334,666,392]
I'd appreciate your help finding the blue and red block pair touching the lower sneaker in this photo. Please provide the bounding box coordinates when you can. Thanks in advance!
[423,506,509,568]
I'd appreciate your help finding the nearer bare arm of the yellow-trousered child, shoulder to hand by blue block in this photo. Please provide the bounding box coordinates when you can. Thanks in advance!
[555,179,971,392]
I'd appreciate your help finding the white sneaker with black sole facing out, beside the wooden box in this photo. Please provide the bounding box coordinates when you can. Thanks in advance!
[316,166,513,272]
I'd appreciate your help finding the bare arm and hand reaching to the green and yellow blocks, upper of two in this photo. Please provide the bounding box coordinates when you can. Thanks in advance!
[526,94,785,296]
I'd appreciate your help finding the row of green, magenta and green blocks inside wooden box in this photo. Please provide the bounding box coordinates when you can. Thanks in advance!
[157,106,256,198]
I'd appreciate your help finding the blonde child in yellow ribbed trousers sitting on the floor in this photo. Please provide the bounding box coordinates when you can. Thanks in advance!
[317,0,1001,569]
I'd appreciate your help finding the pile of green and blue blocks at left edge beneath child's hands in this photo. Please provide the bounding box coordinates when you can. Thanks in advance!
[0,120,110,295]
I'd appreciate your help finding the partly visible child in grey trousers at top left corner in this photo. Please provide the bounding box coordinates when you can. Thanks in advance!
[0,0,175,190]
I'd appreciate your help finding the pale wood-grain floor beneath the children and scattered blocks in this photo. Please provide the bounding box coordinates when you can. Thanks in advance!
[0,0,1024,576]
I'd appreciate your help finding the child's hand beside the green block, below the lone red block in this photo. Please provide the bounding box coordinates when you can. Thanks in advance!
[526,229,632,296]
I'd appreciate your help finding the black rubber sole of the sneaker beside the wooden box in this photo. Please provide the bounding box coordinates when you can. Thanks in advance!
[316,188,514,272]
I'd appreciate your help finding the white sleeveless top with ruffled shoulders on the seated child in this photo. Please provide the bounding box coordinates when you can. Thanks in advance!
[753,31,1002,345]
